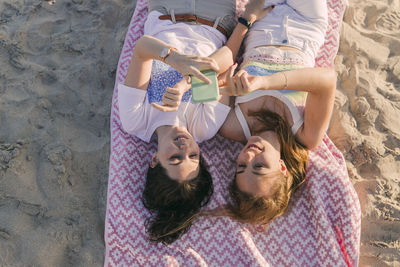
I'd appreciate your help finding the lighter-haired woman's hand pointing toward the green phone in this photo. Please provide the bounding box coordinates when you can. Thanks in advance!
[218,64,261,96]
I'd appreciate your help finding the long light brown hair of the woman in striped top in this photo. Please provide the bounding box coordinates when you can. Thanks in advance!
[228,110,308,225]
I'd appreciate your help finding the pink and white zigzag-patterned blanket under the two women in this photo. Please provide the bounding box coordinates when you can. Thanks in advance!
[104,0,360,266]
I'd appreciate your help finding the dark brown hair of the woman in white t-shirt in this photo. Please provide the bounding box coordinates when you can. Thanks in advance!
[142,157,213,244]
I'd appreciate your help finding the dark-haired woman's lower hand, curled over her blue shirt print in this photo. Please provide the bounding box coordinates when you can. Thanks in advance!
[151,76,190,112]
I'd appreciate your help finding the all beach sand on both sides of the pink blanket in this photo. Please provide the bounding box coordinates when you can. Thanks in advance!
[0,0,400,266]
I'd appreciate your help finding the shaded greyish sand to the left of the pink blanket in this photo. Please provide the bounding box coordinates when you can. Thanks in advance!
[0,0,135,266]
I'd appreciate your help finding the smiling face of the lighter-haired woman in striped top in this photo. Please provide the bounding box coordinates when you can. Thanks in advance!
[236,131,287,197]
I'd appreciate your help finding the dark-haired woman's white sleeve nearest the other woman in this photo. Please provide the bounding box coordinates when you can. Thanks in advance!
[187,101,230,143]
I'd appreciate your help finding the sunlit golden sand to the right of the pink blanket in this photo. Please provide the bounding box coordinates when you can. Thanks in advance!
[330,0,400,266]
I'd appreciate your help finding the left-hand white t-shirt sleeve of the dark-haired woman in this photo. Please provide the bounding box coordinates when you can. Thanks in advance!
[118,84,153,142]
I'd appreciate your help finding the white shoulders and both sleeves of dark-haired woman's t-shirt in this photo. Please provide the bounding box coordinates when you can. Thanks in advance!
[118,84,230,142]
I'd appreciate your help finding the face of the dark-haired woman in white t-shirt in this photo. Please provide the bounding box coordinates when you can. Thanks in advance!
[150,127,200,181]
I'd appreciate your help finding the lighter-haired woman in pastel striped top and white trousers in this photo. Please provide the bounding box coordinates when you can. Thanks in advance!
[216,0,336,225]
